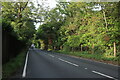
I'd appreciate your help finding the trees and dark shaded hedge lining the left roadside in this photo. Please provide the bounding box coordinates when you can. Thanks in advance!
[1,2,36,64]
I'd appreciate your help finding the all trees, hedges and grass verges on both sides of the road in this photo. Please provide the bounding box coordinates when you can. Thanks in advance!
[0,0,120,77]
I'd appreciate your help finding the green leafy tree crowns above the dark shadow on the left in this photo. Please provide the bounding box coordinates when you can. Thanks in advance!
[2,2,35,43]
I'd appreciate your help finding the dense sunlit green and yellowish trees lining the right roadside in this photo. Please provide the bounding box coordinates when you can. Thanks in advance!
[36,2,120,56]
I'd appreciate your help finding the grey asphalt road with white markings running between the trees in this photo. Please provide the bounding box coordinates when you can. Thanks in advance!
[22,49,118,80]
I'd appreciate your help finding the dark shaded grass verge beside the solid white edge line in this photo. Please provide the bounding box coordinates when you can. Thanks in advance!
[2,50,26,78]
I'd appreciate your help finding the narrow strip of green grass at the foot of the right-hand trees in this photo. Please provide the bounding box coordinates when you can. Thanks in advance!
[55,51,119,61]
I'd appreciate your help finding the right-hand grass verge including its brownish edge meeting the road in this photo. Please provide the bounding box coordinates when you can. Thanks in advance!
[54,50,119,65]
